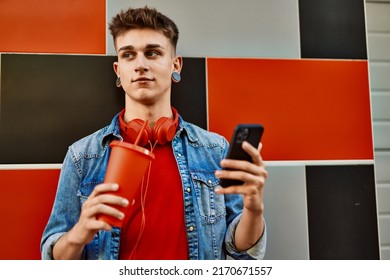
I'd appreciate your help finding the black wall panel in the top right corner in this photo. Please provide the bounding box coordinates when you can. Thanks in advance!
[299,0,367,59]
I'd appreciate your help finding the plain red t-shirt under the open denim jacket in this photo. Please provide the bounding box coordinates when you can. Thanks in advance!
[119,143,188,260]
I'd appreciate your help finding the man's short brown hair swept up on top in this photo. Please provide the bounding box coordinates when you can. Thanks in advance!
[109,6,179,50]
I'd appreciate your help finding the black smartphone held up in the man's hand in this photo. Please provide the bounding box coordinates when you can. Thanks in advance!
[220,124,264,188]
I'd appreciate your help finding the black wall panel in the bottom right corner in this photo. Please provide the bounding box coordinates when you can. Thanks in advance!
[306,165,379,259]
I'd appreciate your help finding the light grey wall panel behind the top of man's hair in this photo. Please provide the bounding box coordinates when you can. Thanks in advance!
[107,0,300,58]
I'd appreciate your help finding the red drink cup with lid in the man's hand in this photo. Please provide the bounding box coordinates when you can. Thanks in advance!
[98,140,154,227]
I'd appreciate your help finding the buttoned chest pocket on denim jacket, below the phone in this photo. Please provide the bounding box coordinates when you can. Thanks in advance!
[191,171,226,224]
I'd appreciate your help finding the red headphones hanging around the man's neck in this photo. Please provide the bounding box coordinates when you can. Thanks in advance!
[119,107,179,146]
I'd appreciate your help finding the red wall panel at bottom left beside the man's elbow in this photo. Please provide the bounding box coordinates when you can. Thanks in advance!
[0,169,60,260]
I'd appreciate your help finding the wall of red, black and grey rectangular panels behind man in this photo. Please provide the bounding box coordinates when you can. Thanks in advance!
[0,0,380,259]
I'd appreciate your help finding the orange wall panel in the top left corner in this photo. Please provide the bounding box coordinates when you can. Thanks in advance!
[0,0,106,54]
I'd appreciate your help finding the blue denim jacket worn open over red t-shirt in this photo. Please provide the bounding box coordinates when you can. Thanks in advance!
[41,115,266,260]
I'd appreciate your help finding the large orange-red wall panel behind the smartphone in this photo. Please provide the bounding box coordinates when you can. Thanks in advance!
[207,58,373,160]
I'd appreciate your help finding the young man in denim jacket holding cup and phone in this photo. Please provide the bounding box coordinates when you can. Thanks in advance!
[41,7,267,259]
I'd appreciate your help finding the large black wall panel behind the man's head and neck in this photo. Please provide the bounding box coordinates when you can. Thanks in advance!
[0,54,207,164]
